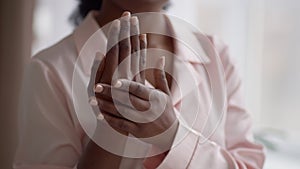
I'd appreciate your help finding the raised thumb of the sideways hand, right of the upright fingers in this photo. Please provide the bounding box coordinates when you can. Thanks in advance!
[154,56,170,95]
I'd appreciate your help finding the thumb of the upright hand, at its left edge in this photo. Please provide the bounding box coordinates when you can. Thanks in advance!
[88,52,105,96]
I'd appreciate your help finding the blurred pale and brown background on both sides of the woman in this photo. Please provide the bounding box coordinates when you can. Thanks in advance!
[0,0,300,169]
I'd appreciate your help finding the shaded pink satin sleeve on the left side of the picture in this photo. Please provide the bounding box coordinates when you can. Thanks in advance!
[13,59,81,169]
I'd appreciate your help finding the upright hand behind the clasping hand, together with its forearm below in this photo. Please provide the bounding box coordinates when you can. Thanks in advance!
[77,12,147,168]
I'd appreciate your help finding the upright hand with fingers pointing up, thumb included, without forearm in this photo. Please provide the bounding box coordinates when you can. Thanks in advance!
[88,12,147,134]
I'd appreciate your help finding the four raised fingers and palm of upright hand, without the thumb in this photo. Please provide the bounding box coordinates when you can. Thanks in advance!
[95,12,146,85]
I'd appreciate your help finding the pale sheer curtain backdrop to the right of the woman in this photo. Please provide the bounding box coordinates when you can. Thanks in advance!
[170,0,300,133]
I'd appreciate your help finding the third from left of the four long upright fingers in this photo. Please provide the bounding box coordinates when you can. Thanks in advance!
[130,16,141,82]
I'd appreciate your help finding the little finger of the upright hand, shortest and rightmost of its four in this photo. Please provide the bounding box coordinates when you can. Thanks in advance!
[139,34,147,84]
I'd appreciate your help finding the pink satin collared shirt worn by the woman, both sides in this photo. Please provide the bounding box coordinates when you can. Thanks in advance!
[14,12,265,169]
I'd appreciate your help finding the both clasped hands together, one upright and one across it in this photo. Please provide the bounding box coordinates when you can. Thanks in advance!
[88,12,178,148]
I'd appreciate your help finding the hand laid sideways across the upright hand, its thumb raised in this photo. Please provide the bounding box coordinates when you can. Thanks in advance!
[97,58,178,149]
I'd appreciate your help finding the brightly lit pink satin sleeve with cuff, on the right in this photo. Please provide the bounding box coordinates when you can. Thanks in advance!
[155,37,265,169]
